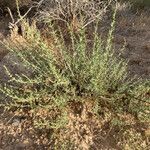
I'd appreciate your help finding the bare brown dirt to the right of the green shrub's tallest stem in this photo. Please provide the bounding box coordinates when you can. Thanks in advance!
[115,12,150,78]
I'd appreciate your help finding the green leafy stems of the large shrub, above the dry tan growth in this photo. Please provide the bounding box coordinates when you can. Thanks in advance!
[1,16,150,122]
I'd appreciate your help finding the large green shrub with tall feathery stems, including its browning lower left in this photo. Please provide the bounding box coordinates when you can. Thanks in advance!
[1,5,150,149]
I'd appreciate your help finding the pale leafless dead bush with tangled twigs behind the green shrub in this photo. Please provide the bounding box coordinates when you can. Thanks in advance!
[38,0,111,28]
